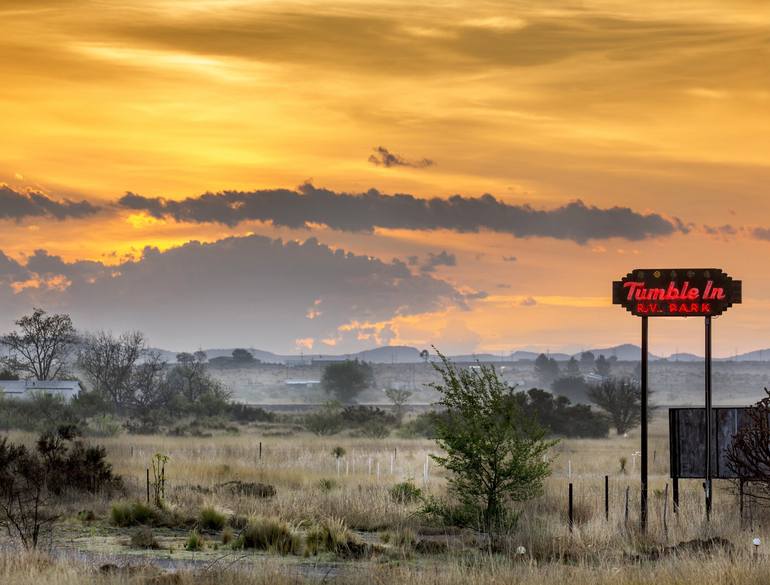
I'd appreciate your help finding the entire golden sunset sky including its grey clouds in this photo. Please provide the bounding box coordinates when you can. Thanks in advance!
[0,0,770,355]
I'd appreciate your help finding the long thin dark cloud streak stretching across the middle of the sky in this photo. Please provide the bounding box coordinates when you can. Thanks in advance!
[118,184,689,243]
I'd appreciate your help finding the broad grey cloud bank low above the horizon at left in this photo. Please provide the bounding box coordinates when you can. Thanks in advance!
[0,236,470,351]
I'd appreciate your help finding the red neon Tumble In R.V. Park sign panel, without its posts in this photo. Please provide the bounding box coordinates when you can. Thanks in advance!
[612,268,742,317]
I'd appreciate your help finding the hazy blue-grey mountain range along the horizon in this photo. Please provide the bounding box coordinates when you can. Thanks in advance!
[156,343,770,364]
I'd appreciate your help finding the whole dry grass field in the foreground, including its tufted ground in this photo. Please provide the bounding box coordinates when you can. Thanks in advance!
[0,415,770,585]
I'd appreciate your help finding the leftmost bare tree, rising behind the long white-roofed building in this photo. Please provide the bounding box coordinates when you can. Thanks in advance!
[0,308,77,380]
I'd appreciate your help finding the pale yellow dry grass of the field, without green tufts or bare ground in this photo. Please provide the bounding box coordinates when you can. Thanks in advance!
[0,417,770,585]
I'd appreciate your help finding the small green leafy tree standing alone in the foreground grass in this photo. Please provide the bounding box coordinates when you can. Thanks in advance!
[430,354,556,533]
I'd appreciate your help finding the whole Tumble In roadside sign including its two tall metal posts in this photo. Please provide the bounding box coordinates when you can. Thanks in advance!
[612,268,743,530]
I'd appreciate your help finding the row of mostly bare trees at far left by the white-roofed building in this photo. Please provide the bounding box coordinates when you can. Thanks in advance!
[0,308,230,424]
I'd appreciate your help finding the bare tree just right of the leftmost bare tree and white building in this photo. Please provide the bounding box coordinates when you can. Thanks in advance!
[78,331,147,412]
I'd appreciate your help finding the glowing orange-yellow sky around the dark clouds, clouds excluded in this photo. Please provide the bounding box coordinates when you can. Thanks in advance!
[0,0,770,355]
